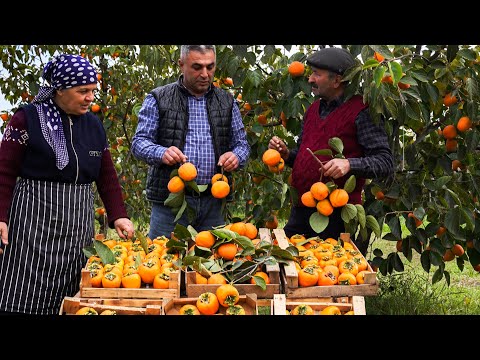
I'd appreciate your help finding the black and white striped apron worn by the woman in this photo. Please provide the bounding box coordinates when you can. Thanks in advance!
[0,179,94,315]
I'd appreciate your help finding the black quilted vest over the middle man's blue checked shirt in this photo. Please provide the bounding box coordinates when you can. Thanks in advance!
[146,78,233,202]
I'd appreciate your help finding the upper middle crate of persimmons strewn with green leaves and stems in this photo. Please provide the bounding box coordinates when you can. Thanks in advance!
[183,222,288,299]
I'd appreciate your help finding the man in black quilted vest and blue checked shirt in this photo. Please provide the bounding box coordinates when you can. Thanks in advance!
[132,45,250,239]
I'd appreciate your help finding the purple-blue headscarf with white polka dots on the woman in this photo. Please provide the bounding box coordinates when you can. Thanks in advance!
[32,54,97,170]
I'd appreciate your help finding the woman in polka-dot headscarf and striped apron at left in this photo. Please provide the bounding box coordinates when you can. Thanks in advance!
[0,54,134,315]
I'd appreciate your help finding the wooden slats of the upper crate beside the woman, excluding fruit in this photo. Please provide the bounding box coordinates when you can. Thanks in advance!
[80,269,180,299]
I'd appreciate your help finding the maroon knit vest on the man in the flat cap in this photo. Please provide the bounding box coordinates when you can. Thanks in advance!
[292,95,368,206]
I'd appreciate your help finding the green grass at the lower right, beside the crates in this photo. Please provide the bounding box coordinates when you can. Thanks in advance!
[365,241,480,315]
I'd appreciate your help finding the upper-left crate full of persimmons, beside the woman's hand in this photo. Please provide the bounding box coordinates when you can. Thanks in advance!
[80,235,181,299]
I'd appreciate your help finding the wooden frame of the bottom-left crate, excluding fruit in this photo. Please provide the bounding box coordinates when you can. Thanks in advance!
[60,296,162,315]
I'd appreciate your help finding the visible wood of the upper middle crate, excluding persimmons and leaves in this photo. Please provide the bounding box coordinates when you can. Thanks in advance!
[185,228,282,299]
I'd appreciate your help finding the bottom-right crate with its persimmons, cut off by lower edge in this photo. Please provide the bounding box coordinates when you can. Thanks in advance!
[272,294,365,315]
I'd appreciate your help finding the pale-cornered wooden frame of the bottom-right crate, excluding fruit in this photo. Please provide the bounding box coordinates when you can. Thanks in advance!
[272,294,366,315]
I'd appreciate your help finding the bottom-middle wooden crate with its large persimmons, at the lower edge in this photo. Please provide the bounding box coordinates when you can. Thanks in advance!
[162,284,258,315]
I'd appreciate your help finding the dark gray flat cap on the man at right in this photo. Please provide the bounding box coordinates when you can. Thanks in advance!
[307,47,355,75]
